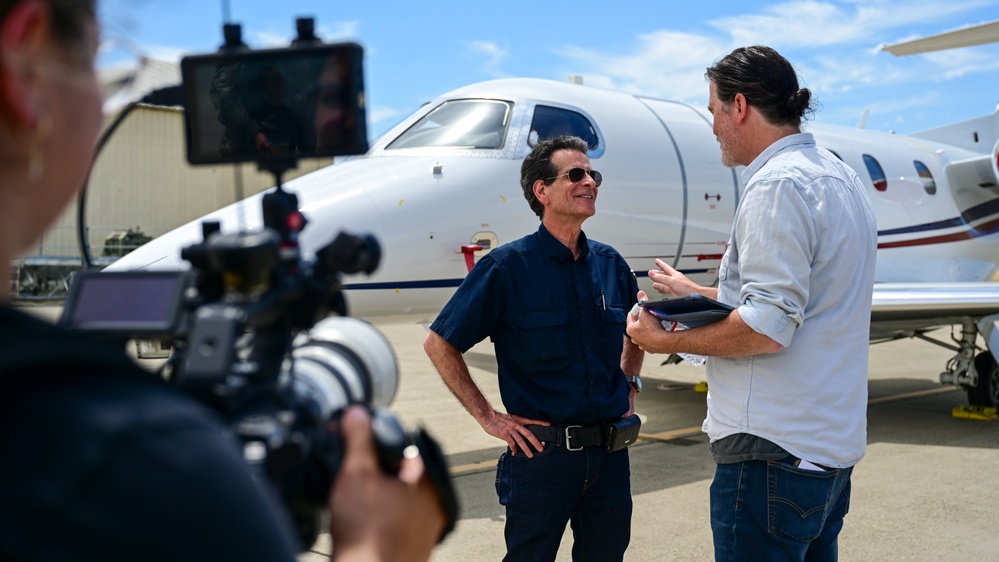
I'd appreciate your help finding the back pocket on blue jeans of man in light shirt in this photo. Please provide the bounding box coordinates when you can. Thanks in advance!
[767,462,839,542]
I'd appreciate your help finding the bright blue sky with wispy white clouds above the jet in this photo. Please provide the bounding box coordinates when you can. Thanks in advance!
[98,0,999,138]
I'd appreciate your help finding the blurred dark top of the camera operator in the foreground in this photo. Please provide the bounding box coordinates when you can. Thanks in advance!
[0,306,297,562]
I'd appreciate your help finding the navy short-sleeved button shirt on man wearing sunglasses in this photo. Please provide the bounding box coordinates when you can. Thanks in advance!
[430,225,638,424]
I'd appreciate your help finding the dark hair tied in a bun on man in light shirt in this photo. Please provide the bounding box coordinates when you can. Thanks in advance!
[704,45,814,127]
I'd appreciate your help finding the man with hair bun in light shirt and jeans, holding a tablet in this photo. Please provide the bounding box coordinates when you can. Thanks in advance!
[628,46,877,561]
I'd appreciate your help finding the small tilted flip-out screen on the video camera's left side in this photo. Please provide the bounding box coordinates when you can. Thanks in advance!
[59,271,190,336]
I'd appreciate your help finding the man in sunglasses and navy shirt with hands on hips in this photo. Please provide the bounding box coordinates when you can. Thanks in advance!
[424,136,643,561]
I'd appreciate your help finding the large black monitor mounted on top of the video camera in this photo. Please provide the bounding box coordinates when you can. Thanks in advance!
[180,43,368,164]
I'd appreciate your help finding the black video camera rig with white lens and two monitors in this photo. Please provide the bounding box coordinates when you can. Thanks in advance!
[60,20,458,548]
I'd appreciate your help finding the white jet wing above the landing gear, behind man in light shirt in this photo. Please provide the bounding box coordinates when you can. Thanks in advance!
[871,282,999,332]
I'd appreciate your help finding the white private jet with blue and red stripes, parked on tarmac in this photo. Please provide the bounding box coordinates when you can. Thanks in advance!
[108,23,999,407]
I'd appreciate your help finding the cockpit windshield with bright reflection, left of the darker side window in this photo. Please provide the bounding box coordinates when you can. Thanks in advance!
[386,100,513,149]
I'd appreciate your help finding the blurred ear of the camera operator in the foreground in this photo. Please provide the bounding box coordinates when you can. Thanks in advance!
[0,0,49,128]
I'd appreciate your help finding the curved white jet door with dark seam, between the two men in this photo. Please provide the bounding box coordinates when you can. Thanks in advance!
[642,99,740,286]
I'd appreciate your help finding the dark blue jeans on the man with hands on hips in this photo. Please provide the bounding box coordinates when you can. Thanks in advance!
[496,443,632,562]
